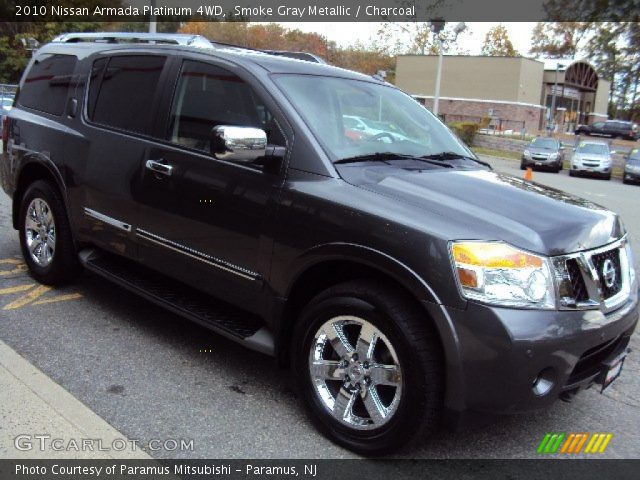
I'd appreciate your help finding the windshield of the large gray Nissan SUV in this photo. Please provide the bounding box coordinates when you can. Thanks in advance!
[274,74,474,162]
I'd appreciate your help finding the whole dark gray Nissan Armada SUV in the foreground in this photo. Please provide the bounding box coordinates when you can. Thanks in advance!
[1,32,638,454]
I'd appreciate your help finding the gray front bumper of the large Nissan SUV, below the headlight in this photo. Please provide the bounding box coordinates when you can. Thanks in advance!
[448,291,638,414]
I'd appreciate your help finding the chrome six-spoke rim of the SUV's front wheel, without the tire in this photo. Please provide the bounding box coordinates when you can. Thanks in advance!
[309,316,402,430]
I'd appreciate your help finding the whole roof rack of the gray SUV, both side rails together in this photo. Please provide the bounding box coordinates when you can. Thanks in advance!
[53,32,326,63]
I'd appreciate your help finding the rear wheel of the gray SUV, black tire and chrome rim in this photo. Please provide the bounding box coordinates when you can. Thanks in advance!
[18,180,80,285]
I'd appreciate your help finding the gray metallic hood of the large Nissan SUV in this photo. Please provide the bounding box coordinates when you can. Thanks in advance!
[340,165,624,256]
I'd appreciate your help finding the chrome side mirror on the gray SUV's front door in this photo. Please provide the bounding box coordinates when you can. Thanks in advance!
[210,125,267,163]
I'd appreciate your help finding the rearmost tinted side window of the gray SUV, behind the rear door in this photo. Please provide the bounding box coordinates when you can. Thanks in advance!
[18,55,78,115]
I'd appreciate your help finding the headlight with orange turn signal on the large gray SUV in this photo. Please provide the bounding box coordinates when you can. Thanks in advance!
[451,241,556,309]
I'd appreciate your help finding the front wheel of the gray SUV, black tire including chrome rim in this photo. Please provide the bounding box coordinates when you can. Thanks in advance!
[292,281,444,455]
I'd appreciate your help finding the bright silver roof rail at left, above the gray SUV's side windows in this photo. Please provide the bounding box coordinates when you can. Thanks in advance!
[53,32,214,48]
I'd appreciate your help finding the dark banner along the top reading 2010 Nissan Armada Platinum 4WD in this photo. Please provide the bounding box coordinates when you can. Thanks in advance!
[0,0,640,22]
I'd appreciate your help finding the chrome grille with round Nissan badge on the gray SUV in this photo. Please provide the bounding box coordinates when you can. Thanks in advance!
[551,238,631,312]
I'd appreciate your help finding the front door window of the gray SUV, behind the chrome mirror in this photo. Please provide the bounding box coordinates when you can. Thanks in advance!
[167,61,285,152]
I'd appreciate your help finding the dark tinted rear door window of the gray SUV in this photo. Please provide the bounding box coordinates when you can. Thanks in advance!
[87,56,166,133]
